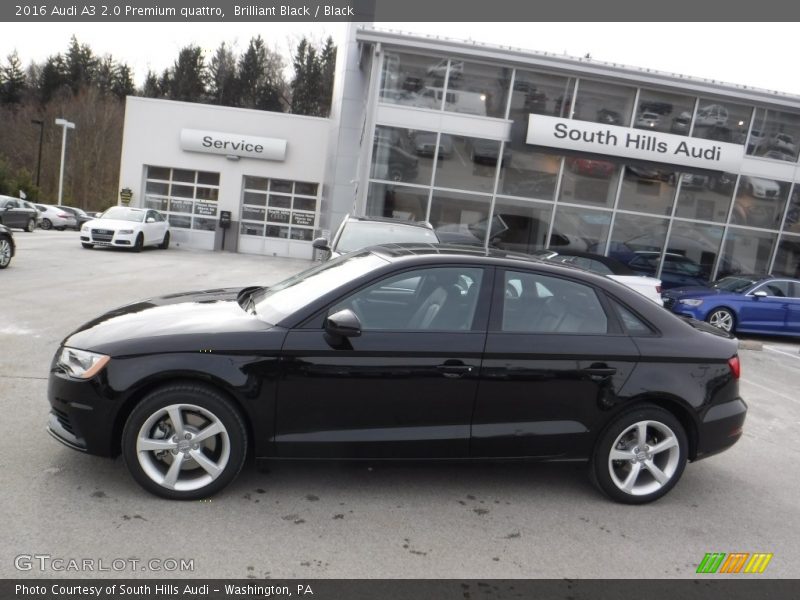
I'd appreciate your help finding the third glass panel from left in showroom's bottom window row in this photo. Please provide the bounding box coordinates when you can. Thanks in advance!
[489,198,553,253]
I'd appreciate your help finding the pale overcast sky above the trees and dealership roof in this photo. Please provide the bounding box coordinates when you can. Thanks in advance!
[0,23,800,95]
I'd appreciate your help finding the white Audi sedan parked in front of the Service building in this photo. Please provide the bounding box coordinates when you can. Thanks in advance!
[81,206,169,252]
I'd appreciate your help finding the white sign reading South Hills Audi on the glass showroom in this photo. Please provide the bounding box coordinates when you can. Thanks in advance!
[526,115,744,173]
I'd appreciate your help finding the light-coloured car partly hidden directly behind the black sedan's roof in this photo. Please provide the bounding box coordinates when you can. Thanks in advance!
[311,215,439,259]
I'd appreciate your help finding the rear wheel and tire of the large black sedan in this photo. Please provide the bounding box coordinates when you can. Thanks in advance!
[591,404,689,504]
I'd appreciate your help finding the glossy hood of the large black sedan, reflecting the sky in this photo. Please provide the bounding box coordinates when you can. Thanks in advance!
[63,288,282,356]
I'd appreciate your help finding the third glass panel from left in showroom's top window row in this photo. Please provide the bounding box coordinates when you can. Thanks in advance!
[509,69,575,118]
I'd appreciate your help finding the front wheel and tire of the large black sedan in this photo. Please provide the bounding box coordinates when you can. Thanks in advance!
[122,382,247,500]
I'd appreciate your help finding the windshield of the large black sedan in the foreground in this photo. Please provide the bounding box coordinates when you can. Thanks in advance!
[253,252,386,324]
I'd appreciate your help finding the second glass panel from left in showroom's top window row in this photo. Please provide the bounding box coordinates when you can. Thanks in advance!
[440,60,511,118]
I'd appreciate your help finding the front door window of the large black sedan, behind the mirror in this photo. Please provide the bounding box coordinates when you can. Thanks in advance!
[328,267,483,331]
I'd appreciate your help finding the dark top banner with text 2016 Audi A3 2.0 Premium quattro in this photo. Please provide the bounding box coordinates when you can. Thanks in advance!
[0,0,800,21]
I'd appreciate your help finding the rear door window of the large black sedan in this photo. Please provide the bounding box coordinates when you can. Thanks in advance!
[501,271,608,334]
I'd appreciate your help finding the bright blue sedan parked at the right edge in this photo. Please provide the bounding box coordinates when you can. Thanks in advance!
[664,275,800,336]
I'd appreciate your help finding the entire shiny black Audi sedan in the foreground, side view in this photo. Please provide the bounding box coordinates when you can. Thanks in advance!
[48,245,747,504]
